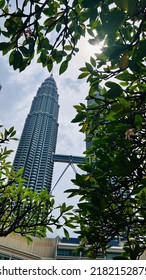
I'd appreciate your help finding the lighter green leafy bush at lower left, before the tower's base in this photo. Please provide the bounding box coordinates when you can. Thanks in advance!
[0,127,74,238]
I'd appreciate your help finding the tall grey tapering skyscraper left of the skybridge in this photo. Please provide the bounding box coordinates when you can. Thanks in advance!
[13,75,59,192]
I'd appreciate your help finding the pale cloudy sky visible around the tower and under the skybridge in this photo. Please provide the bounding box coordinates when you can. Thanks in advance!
[0,34,98,236]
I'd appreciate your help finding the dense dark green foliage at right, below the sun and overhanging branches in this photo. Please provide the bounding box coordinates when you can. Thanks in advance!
[69,87,146,259]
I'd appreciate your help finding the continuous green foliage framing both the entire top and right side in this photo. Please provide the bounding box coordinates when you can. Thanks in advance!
[0,0,146,259]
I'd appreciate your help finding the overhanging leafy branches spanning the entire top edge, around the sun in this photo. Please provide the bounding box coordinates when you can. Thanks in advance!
[0,0,146,74]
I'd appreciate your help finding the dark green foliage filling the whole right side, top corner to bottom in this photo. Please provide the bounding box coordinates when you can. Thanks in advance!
[71,1,146,259]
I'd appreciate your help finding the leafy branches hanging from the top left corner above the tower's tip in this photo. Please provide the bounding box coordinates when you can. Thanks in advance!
[0,0,85,74]
